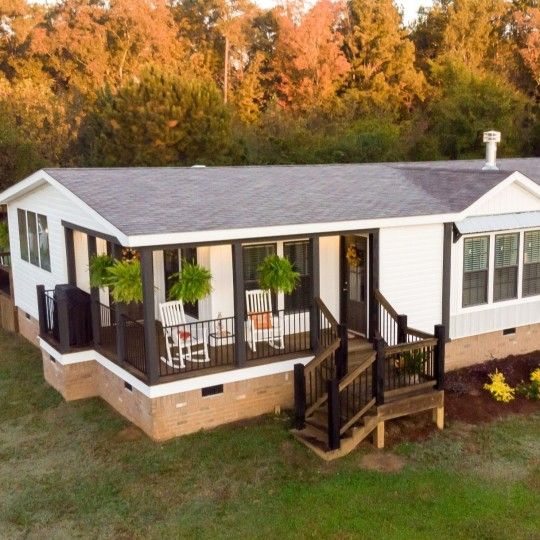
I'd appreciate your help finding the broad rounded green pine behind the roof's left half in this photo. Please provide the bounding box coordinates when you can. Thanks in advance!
[79,68,230,166]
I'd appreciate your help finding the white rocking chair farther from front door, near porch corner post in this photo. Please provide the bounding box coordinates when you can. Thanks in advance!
[159,300,210,369]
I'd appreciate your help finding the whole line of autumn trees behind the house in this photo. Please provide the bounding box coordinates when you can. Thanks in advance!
[0,0,540,186]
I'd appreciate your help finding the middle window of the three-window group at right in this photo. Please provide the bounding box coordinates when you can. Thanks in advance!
[493,233,519,302]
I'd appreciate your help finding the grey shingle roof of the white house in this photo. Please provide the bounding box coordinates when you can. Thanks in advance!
[46,159,540,236]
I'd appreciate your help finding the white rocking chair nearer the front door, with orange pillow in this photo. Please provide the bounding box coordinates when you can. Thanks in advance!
[246,289,285,352]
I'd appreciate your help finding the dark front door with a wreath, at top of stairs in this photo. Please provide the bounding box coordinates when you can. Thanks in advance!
[342,236,368,335]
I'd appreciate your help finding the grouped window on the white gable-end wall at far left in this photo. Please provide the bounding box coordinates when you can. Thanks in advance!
[17,209,51,272]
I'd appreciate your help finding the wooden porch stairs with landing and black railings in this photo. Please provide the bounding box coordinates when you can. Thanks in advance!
[292,296,445,461]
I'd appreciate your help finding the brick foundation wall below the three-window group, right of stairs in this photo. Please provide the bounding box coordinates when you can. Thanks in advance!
[445,324,540,371]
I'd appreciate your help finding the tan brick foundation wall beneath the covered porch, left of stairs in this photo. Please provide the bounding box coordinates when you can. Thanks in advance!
[43,351,293,440]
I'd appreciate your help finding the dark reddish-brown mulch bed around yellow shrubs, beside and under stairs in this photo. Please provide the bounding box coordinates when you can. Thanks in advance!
[386,351,540,447]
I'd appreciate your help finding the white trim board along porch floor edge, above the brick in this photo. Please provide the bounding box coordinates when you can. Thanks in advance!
[39,338,313,399]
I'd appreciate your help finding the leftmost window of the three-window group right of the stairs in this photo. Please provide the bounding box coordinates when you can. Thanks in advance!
[463,236,489,307]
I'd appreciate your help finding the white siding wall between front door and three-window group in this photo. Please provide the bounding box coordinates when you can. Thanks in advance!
[379,223,444,332]
